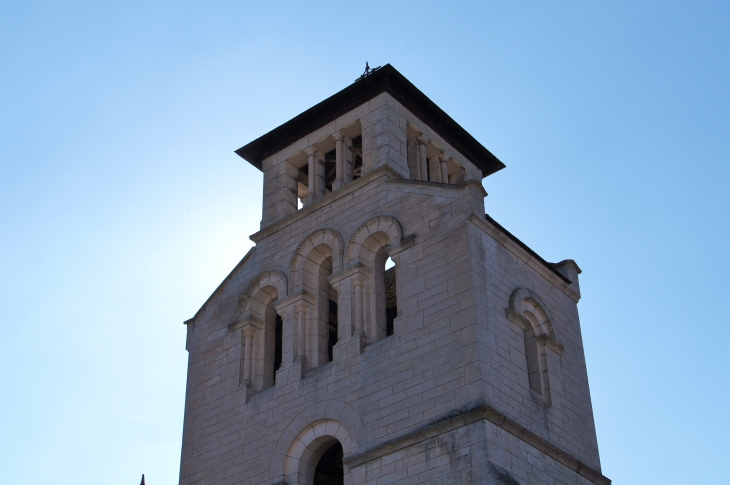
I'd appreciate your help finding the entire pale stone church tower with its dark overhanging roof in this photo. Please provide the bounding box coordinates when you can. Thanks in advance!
[180,65,611,485]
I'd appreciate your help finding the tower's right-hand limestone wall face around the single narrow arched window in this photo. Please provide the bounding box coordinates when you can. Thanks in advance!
[471,219,600,470]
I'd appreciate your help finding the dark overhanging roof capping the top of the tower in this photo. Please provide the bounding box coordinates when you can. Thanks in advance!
[236,64,505,177]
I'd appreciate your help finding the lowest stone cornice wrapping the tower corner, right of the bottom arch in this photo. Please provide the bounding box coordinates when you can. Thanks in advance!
[343,401,611,485]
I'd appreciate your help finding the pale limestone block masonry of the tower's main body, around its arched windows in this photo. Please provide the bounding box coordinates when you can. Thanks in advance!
[180,164,599,485]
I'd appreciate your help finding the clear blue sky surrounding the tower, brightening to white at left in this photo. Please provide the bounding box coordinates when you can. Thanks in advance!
[0,0,730,485]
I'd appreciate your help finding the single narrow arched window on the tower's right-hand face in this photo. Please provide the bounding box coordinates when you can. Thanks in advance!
[506,288,563,404]
